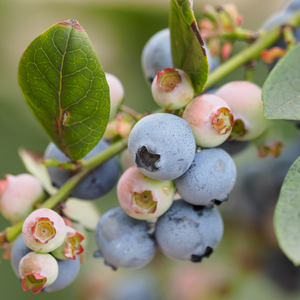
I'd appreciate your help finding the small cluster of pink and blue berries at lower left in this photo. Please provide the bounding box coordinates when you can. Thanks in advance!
[11,208,84,294]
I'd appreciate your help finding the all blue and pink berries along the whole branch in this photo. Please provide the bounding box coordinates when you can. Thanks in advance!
[0,8,278,293]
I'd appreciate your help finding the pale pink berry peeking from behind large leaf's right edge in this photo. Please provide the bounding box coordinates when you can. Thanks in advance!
[105,73,124,121]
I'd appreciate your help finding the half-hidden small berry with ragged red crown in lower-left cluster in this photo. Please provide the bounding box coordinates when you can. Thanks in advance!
[52,226,84,260]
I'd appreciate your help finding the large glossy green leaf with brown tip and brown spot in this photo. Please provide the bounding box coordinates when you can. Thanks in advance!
[18,19,110,160]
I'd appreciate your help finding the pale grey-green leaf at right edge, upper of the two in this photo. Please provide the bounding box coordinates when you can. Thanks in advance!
[262,45,300,120]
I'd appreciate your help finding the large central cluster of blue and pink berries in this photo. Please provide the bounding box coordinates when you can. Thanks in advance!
[95,30,269,269]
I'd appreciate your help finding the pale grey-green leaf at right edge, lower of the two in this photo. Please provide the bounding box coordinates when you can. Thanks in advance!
[274,157,300,265]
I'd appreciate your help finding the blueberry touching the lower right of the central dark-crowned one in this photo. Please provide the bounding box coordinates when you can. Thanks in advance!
[175,148,236,205]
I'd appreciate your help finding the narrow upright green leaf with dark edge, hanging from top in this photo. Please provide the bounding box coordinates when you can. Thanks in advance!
[170,0,208,94]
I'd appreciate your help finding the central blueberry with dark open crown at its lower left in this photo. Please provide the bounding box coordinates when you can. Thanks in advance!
[128,113,196,180]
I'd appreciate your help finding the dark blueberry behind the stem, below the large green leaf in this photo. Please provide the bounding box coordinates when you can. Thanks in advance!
[44,140,119,200]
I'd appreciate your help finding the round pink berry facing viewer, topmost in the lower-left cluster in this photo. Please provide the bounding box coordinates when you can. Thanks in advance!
[22,208,67,253]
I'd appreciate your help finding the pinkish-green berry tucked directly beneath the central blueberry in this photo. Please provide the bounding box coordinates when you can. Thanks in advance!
[117,166,175,220]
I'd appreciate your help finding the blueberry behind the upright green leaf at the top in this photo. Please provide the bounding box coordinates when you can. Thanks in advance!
[142,28,219,84]
